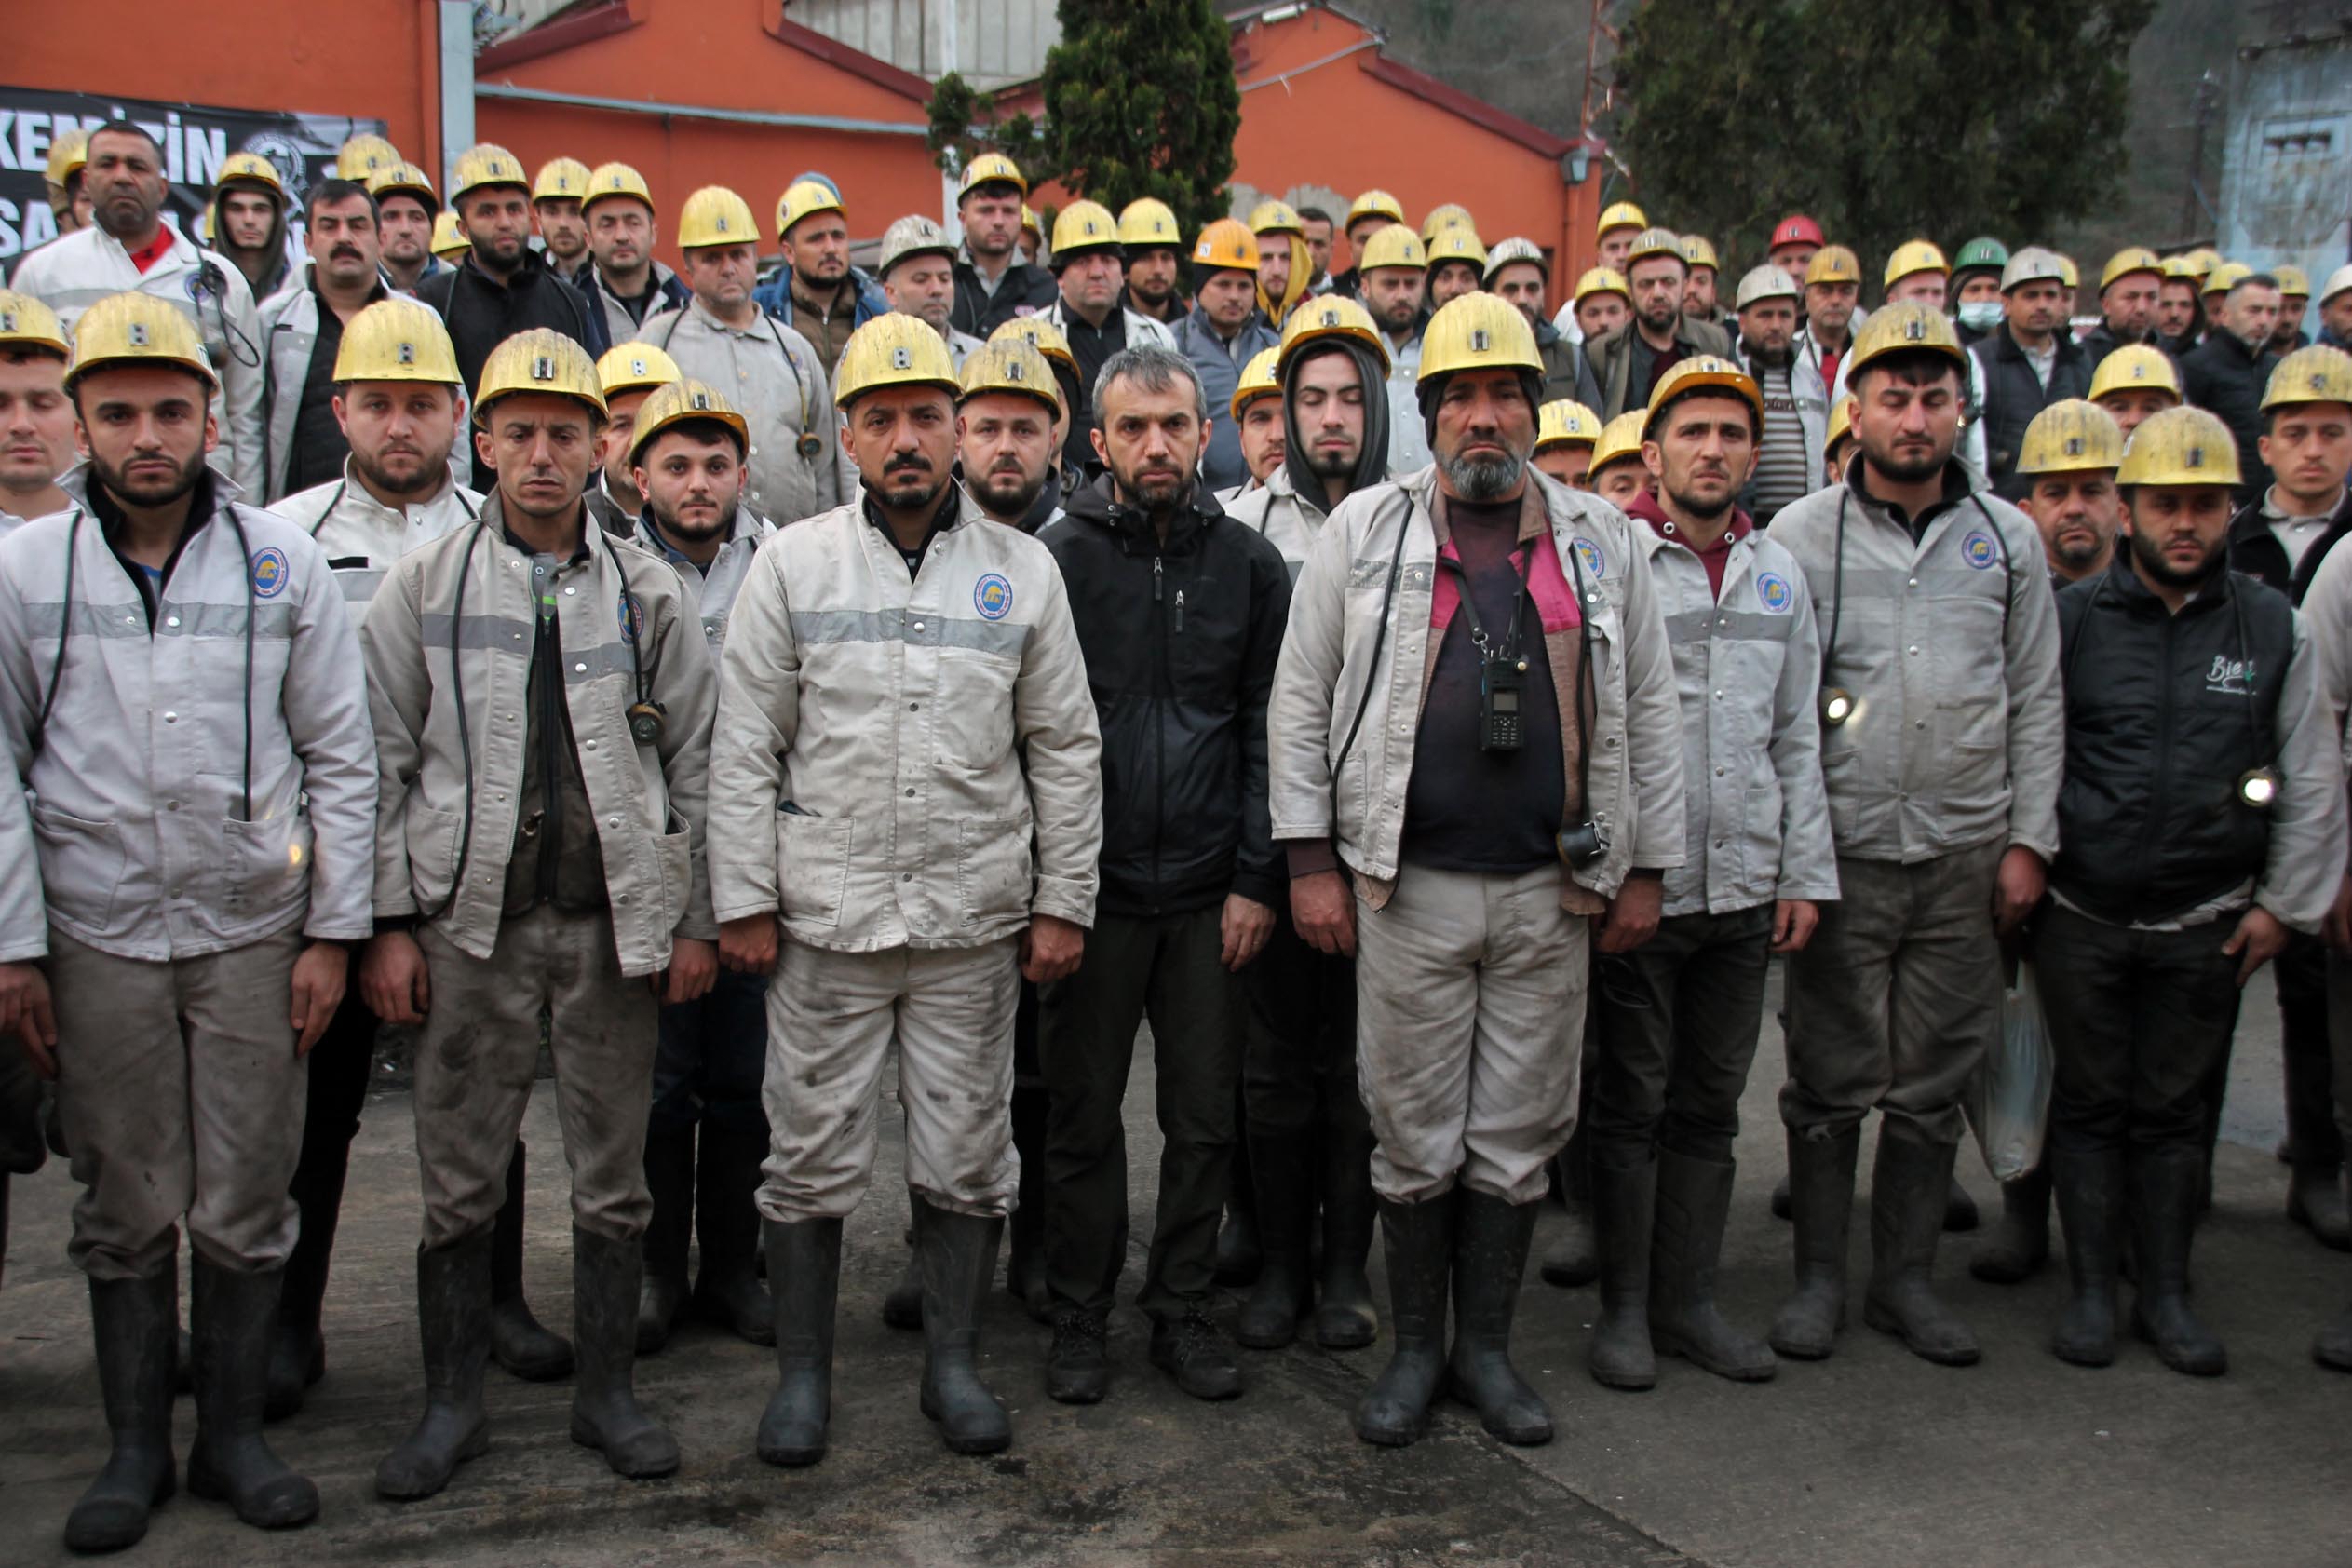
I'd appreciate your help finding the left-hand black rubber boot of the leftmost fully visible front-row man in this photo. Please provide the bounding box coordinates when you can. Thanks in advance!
[66,1264,179,1551]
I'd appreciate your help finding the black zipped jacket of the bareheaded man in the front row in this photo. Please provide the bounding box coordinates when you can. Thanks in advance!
[1037,478,1291,914]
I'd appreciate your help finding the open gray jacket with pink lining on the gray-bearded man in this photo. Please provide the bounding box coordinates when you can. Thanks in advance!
[1268,467,1684,898]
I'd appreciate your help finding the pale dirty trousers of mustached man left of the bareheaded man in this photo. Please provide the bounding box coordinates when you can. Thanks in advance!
[760,938,1021,1223]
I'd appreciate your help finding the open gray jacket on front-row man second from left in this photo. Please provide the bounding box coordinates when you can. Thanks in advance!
[359,496,717,976]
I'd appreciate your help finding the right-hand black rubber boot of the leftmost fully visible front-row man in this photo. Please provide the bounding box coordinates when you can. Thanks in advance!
[188,1255,318,1531]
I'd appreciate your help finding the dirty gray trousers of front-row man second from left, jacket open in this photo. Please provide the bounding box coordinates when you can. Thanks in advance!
[416,905,656,1246]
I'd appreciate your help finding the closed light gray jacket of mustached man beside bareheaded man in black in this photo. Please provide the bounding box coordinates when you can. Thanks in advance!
[710,492,1103,953]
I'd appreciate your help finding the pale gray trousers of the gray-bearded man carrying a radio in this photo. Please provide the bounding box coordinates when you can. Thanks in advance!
[1355,865,1590,1204]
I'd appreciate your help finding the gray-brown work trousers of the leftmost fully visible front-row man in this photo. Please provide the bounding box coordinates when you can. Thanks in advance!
[48,926,308,1278]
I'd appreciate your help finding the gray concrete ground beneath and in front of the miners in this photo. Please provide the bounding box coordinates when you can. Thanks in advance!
[0,980,2352,1568]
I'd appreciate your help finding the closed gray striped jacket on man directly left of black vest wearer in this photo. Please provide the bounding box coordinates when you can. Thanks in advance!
[1771,484,2065,865]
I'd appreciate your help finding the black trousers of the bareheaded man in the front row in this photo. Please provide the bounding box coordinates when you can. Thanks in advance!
[1037,902,1247,1318]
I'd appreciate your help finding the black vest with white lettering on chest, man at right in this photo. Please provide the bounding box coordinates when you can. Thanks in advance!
[2051,557,2295,940]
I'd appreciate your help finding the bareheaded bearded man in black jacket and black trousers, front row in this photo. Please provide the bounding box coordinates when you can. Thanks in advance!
[1037,348,1291,1403]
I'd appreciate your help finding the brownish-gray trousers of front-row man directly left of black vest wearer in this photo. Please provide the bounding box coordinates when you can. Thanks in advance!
[1780,844,2007,1145]
